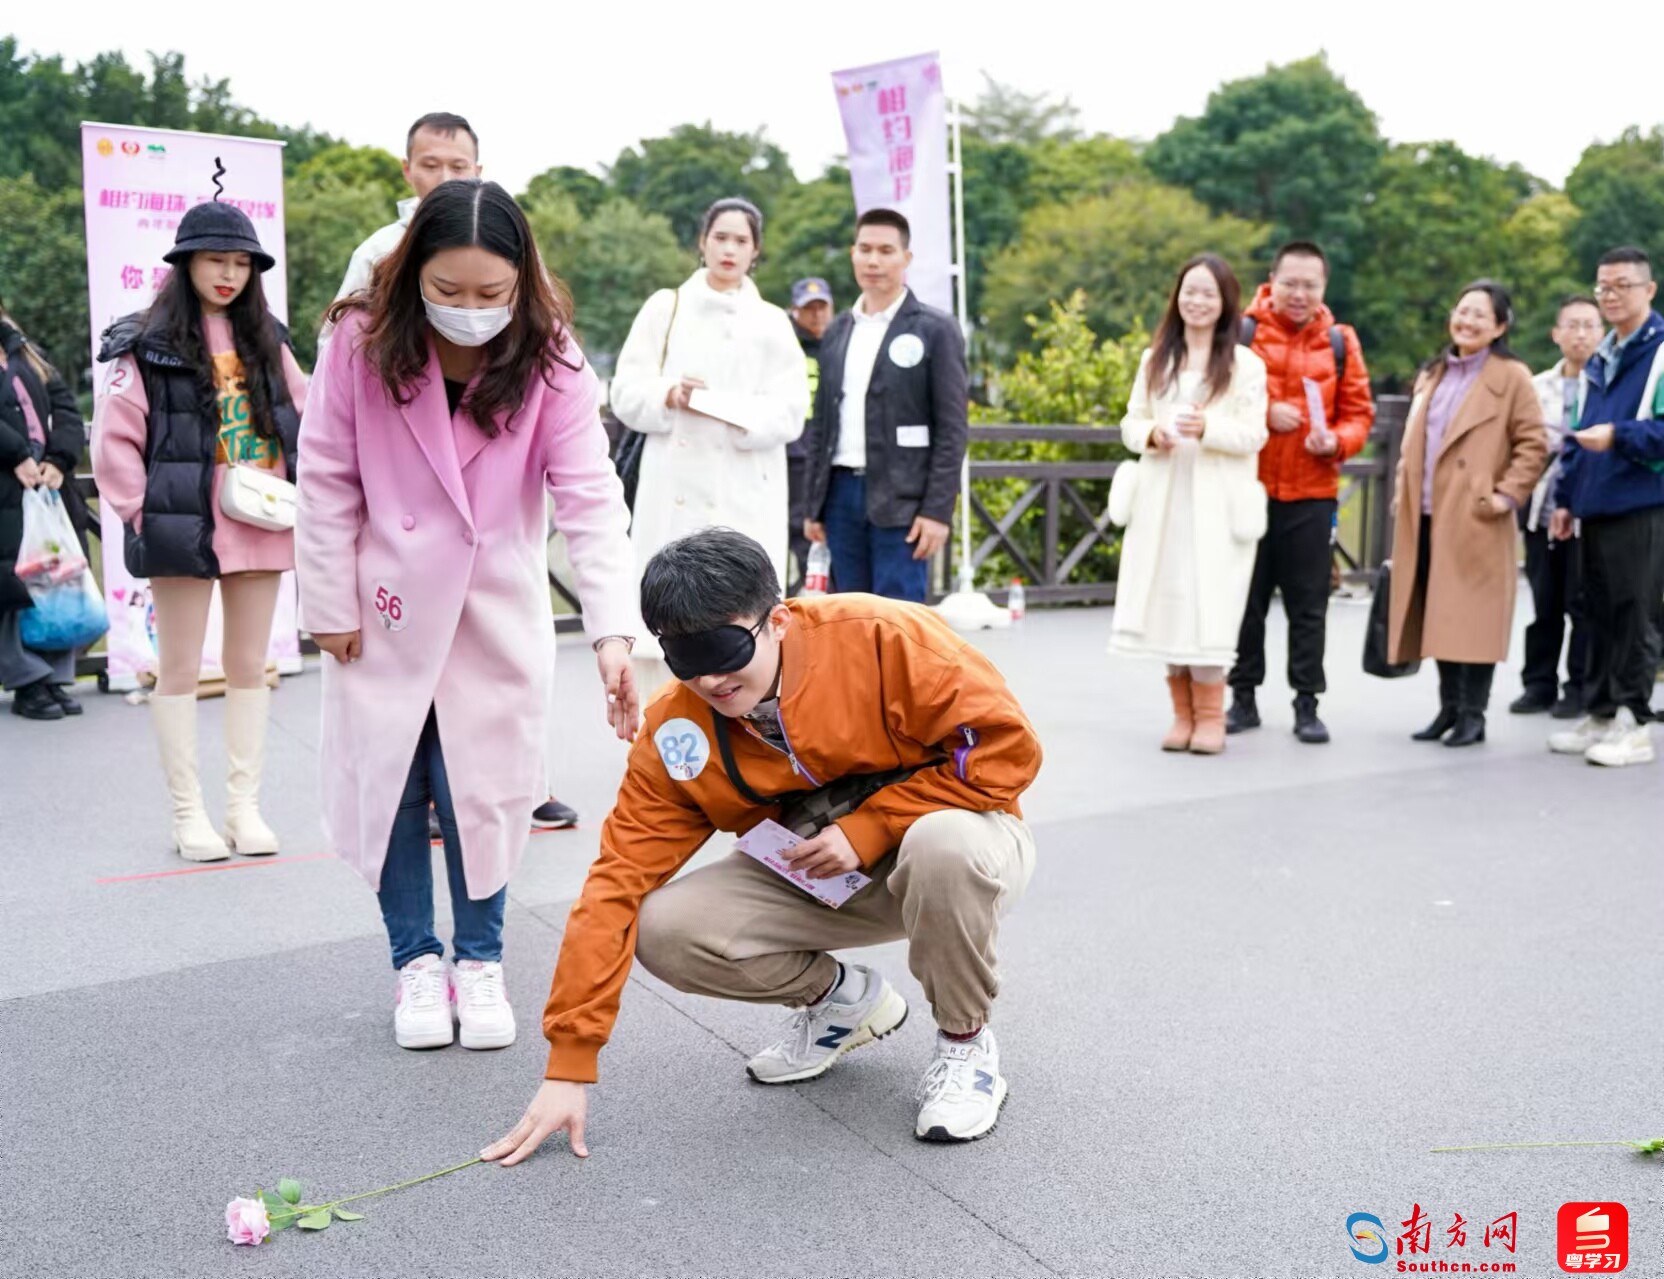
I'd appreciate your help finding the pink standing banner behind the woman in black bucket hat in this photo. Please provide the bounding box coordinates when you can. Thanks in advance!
[82,121,301,690]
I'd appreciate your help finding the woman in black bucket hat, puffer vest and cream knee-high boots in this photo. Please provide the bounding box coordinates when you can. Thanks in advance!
[93,203,306,862]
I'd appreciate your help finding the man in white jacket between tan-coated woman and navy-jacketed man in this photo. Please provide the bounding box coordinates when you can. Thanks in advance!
[1508,294,1606,720]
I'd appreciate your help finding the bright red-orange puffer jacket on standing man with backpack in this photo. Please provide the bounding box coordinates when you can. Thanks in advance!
[1243,284,1374,502]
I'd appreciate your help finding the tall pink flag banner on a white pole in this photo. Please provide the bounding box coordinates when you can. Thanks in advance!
[832,53,953,311]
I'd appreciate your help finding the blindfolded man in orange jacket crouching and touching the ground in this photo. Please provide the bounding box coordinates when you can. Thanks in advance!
[484,529,1040,1164]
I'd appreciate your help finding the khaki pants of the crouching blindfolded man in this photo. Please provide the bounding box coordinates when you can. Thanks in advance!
[636,808,1035,1035]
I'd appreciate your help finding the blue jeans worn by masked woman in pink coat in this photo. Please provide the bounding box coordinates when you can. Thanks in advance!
[376,710,509,968]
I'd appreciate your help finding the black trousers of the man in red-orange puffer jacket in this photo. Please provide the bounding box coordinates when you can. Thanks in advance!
[1228,497,1335,694]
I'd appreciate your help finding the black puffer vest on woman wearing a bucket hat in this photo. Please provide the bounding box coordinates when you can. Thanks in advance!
[98,314,301,577]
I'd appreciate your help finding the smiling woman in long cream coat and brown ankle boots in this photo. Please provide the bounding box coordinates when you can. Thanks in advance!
[1110,254,1266,755]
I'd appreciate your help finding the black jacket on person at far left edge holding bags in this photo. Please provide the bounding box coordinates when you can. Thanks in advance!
[0,321,87,612]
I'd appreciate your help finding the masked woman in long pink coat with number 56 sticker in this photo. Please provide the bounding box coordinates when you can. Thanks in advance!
[295,180,639,1048]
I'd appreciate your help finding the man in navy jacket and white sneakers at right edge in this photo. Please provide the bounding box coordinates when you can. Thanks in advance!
[1549,248,1664,768]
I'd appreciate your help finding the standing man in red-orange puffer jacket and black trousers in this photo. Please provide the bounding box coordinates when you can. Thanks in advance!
[1226,240,1374,743]
